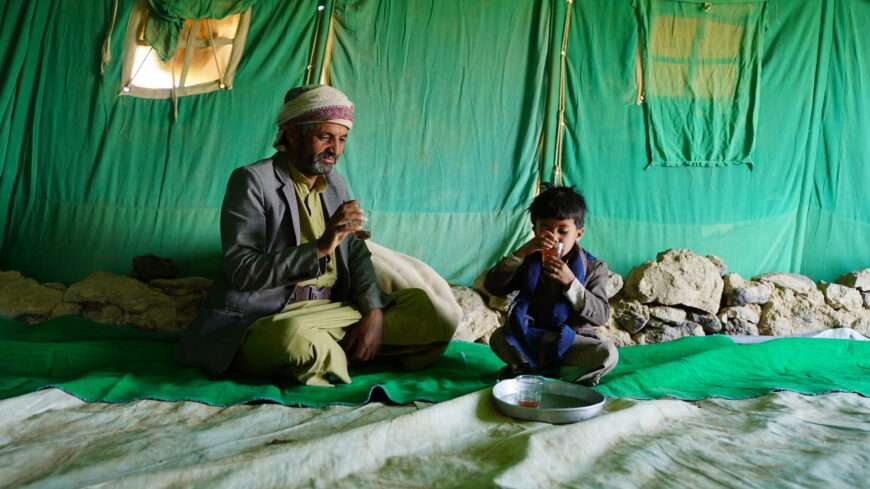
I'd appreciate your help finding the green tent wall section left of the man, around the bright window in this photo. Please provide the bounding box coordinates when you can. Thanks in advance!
[0,0,317,282]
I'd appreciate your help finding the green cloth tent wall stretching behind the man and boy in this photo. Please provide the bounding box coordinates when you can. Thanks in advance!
[0,0,870,284]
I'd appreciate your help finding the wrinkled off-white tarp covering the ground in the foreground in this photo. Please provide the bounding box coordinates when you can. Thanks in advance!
[0,390,870,488]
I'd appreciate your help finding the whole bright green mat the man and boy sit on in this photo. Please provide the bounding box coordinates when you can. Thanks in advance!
[0,317,870,407]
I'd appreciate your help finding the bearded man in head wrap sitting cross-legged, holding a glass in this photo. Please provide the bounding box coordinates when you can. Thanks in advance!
[176,85,453,386]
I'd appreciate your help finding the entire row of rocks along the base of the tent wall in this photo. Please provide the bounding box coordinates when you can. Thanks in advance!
[0,249,870,346]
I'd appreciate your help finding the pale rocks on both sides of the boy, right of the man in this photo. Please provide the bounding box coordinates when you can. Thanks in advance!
[454,249,870,346]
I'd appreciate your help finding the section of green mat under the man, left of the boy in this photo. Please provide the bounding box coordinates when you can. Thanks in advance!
[0,316,503,407]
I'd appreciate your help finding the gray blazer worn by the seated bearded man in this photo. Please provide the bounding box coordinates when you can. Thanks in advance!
[175,153,386,374]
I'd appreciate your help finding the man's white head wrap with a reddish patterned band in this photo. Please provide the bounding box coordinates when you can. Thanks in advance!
[272,85,353,150]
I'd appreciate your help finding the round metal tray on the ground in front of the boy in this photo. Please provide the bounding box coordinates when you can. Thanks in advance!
[492,379,607,424]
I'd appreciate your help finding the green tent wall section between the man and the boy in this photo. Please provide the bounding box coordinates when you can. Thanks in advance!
[329,0,550,283]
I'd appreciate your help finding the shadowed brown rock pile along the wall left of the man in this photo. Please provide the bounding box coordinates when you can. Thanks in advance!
[0,271,212,331]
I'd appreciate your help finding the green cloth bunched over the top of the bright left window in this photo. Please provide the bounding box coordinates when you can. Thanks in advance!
[143,0,257,61]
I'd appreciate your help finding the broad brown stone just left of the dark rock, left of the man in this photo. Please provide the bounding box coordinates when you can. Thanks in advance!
[63,272,173,314]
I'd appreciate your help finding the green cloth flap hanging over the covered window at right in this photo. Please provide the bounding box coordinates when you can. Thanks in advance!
[638,0,766,166]
